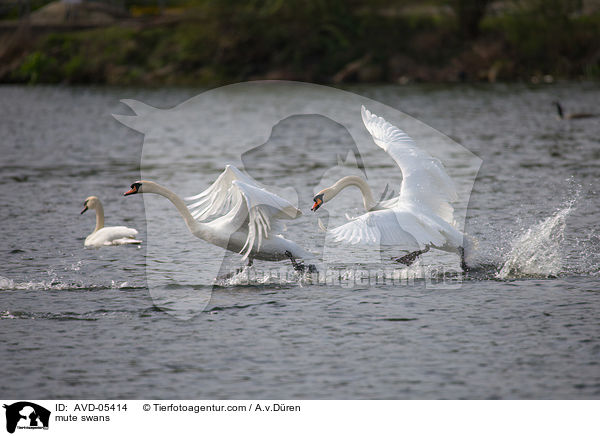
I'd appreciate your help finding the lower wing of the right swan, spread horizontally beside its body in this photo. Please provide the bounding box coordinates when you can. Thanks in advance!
[330,209,446,251]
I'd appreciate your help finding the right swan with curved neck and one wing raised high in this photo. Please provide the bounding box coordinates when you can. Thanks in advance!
[311,106,467,271]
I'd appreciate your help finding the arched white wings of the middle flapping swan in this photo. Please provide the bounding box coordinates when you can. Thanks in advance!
[186,165,302,259]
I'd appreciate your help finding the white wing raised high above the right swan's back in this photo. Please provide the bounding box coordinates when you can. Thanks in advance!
[361,106,458,223]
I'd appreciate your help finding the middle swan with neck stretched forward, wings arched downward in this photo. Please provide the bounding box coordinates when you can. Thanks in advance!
[124,165,315,271]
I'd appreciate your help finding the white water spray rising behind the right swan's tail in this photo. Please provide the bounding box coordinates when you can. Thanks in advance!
[496,204,577,280]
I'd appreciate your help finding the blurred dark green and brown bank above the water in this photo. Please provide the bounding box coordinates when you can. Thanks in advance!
[0,0,600,85]
